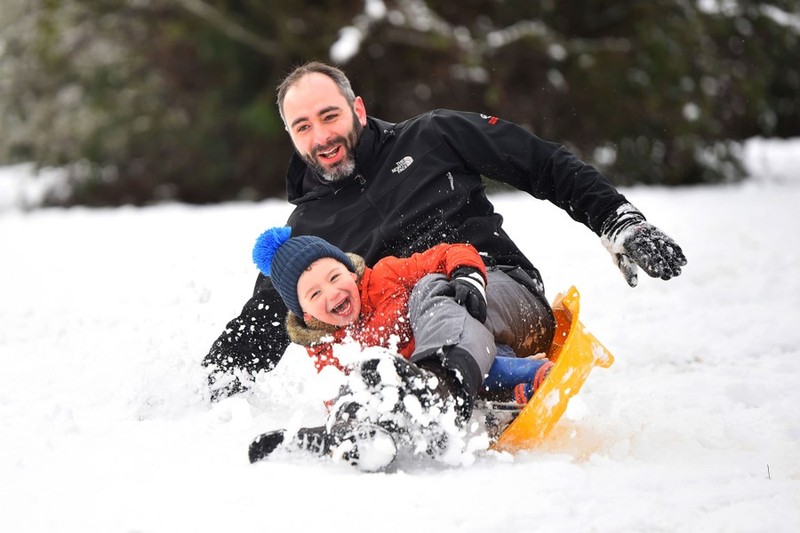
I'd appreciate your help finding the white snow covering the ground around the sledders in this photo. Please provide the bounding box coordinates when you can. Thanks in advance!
[0,140,800,533]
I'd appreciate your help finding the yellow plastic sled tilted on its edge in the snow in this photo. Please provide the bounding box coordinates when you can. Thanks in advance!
[492,286,614,453]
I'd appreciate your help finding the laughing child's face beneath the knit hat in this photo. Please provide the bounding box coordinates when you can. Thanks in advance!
[297,257,361,327]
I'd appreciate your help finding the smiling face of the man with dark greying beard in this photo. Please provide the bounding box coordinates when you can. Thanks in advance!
[283,72,367,182]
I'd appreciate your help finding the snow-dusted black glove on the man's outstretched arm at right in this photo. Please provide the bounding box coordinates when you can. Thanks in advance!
[601,203,686,287]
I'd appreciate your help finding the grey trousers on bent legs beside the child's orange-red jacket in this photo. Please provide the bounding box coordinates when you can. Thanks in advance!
[408,269,553,376]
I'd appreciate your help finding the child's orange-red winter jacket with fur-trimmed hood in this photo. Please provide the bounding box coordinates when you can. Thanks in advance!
[287,244,486,371]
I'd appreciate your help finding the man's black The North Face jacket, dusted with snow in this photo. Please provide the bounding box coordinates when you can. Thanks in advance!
[204,110,626,396]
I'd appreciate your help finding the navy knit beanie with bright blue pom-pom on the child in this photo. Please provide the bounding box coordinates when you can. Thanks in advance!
[253,226,355,319]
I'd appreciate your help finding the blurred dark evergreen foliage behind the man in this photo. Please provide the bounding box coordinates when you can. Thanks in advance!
[0,0,800,205]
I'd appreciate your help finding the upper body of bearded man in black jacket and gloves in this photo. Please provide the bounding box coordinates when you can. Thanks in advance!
[203,62,686,397]
